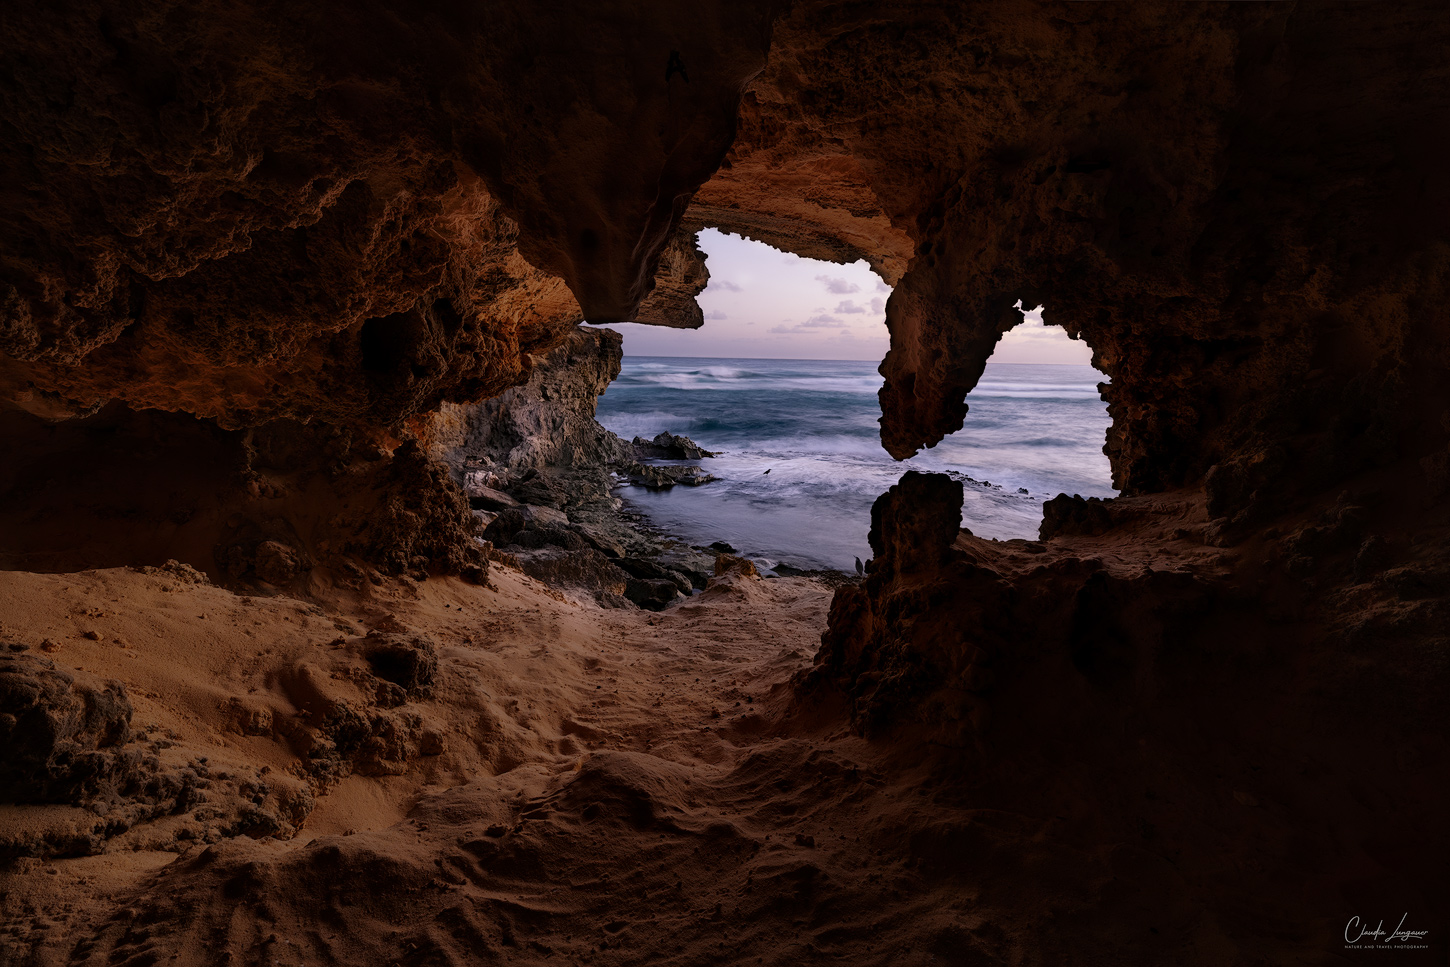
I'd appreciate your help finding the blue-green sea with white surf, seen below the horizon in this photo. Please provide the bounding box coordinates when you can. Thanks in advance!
[597,357,1115,571]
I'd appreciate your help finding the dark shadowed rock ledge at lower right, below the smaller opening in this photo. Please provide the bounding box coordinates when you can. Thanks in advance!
[802,474,1450,963]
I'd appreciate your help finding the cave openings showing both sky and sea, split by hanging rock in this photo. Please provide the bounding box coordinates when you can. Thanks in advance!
[597,231,1112,571]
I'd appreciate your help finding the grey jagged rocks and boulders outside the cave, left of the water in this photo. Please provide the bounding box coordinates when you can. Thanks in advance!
[431,326,856,610]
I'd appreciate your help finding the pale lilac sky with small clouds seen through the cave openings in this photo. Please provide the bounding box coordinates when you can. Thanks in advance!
[610,229,1092,364]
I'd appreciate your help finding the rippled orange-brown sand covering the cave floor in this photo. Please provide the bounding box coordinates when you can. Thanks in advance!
[0,567,1012,964]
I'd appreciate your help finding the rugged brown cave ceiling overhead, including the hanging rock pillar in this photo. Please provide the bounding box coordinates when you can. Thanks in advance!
[0,1,1450,502]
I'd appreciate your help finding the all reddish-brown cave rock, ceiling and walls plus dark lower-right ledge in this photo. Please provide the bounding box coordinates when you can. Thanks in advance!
[0,0,1450,963]
